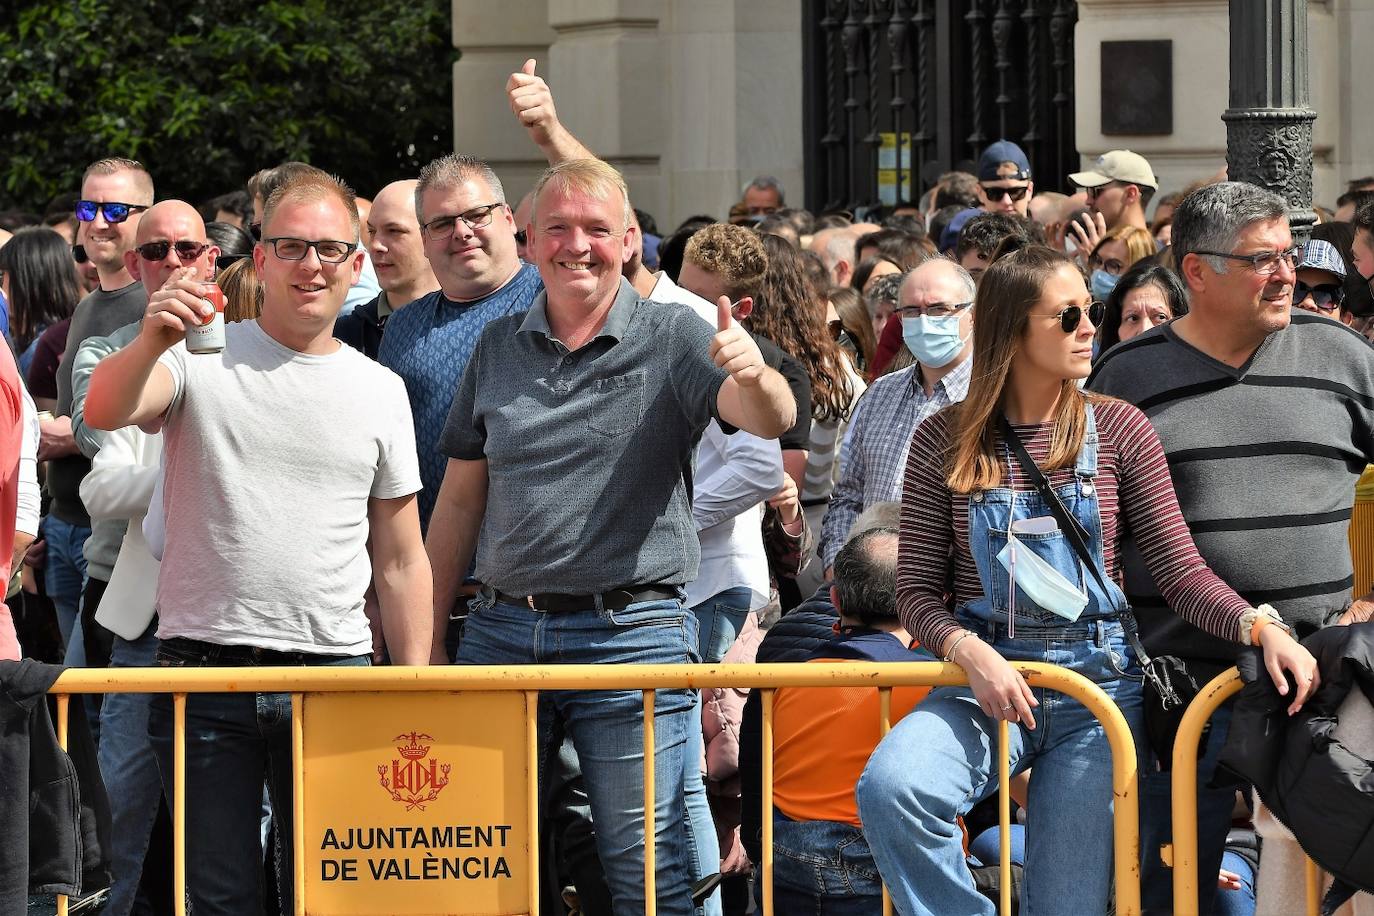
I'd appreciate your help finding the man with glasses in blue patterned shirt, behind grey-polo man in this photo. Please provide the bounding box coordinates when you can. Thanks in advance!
[376,154,544,529]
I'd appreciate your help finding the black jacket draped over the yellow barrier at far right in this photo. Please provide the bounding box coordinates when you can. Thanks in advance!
[1220,622,1374,891]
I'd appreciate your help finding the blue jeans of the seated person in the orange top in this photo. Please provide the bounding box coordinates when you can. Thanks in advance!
[760,812,882,916]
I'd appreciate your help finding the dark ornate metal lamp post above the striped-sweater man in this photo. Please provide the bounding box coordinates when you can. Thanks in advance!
[1221,0,1316,243]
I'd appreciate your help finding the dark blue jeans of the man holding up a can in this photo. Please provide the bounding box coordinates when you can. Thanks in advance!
[148,640,370,916]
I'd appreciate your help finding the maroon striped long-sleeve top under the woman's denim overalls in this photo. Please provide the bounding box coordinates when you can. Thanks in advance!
[897,401,1250,652]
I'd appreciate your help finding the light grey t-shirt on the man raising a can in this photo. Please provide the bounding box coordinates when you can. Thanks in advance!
[158,321,420,655]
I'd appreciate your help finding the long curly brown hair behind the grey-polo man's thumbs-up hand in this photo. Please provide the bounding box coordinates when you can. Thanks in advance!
[747,235,855,420]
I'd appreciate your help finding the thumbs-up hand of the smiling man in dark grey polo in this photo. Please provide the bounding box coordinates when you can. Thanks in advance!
[710,295,797,439]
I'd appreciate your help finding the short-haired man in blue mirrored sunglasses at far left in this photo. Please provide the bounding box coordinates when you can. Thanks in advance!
[47,158,155,665]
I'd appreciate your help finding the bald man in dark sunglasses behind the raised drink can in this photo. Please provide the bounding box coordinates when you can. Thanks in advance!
[71,201,220,916]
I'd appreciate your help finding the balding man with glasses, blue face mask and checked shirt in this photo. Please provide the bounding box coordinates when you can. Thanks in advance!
[820,260,976,573]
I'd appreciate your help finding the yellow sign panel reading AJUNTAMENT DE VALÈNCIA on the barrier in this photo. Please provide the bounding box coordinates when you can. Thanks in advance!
[297,692,533,916]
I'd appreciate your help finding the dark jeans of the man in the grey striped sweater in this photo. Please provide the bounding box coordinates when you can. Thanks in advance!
[1140,703,1235,916]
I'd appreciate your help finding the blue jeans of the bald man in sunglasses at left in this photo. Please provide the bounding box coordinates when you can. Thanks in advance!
[100,621,162,916]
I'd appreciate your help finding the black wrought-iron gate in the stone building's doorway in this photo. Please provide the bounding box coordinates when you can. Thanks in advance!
[802,0,1079,211]
